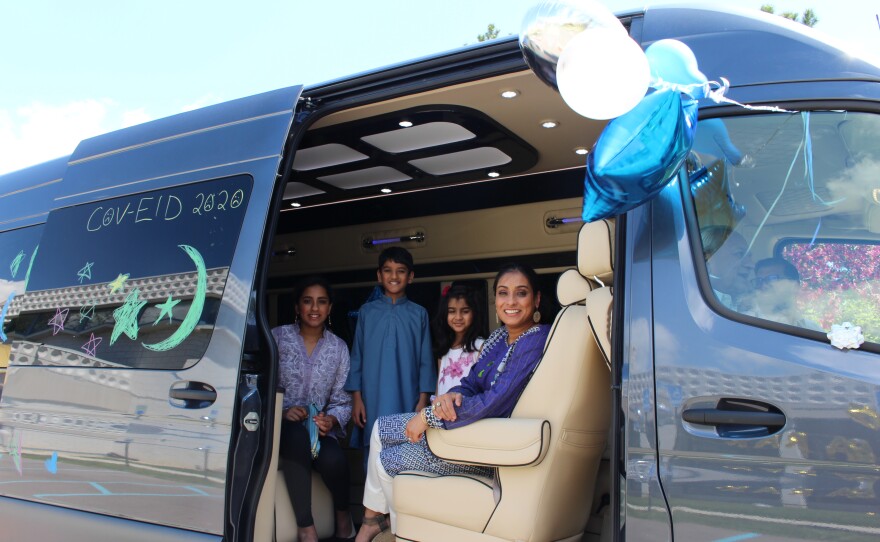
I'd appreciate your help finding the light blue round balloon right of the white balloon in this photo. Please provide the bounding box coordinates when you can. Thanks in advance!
[645,39,708,99]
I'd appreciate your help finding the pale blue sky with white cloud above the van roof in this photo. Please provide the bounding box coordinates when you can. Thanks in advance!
[0,0,880,174]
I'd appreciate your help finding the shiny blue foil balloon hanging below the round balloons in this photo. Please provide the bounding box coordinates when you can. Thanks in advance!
[583,90,697,222]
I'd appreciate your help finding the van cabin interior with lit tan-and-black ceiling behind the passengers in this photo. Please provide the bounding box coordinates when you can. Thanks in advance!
[264,66,610,540]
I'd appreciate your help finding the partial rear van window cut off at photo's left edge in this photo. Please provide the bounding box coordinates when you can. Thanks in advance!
[0,225,43,392]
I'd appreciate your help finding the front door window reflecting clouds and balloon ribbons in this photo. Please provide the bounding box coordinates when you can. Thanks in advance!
[687,111,880,343]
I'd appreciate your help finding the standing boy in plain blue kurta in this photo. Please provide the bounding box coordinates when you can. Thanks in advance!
[345,247,437,458]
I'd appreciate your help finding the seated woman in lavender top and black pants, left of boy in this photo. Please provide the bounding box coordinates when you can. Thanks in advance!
[272,277,354,542]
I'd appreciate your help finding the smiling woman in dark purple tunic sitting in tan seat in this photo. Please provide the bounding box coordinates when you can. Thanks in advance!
[356,264,549,542]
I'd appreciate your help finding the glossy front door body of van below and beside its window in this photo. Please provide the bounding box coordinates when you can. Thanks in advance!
[652,165,880,541]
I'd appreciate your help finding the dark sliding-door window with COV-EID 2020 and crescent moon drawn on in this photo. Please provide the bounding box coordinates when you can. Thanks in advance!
[6,176,252,369]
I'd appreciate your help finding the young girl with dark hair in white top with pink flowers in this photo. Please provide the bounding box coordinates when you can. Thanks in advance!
[432,282,486,395]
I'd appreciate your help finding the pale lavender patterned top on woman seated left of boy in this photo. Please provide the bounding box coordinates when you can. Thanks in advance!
[272,324,351,438]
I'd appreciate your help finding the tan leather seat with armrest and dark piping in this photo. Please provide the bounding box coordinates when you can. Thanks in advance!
[394,221,614,542]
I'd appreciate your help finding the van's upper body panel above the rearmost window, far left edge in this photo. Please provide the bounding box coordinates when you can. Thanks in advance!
[0,157,67,231]
